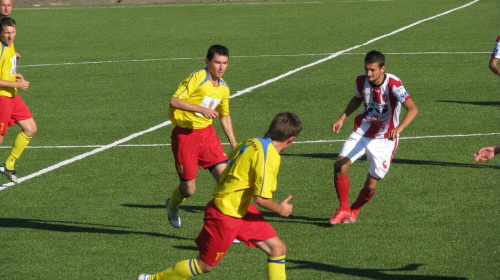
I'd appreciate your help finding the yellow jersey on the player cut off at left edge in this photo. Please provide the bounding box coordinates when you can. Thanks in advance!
[0,42,17,98]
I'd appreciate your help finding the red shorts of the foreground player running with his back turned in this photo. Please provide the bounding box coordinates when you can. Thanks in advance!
[195,200,278,265]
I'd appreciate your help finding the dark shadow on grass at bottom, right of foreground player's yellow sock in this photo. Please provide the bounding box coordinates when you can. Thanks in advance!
[286,259,467,280]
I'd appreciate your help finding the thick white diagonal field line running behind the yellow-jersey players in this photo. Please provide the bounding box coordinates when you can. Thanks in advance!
[0,0,479,191]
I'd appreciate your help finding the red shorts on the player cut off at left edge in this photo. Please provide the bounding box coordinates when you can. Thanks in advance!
[0,95,33,135]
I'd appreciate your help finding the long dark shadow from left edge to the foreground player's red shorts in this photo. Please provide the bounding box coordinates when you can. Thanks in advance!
[0,218,192,240]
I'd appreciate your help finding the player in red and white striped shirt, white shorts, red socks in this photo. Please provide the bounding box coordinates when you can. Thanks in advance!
[329,51,418,225]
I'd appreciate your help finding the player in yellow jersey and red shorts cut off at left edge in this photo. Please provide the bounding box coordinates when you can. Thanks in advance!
[0,17,37,183]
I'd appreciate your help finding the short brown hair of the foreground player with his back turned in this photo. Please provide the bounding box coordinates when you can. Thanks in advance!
[265,112,302,141]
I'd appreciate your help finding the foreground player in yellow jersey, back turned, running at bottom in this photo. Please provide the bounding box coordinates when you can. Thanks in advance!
[137,112,302,280]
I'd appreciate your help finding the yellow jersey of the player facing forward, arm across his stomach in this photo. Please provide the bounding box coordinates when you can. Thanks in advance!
[168,68,230,129]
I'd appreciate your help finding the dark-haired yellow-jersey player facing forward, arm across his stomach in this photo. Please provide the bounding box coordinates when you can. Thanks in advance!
[165,45,237,228]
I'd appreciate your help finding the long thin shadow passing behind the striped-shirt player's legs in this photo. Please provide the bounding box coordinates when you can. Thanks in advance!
[282,153,498,169]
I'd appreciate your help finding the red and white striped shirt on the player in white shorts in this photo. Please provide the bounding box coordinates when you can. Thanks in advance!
[354,73,411,138]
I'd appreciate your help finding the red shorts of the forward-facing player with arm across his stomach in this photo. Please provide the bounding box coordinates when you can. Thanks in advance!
[172,125,227,181]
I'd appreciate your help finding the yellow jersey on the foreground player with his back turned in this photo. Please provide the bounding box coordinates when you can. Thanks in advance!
[212,138,281,218]
